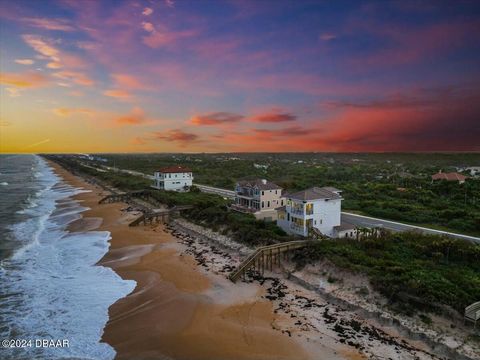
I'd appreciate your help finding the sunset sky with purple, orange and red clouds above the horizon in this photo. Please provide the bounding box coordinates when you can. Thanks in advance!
[0,0,480,153]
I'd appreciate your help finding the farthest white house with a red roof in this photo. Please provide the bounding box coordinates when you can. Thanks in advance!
[152,166,193,191]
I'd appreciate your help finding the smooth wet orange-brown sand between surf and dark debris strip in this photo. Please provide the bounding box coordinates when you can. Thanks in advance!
[47,163,350,360]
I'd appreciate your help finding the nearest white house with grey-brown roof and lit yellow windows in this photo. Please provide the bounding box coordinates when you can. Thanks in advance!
[277,187,355,237]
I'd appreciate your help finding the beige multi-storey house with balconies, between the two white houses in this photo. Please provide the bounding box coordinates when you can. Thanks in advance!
[232,179,284,220]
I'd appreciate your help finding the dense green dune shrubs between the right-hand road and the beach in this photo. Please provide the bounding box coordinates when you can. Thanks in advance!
[294,232,480,313]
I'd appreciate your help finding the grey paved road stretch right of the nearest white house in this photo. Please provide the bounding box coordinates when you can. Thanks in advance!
[342,212,480,243]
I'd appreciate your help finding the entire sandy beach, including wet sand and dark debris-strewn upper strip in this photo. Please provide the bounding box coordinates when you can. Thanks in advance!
[46,164,476,359]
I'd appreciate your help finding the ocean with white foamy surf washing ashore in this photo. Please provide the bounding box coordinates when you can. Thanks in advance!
[0,155,135,359]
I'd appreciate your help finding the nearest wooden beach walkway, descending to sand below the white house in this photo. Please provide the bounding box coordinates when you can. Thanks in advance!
[229,240,311,282]
